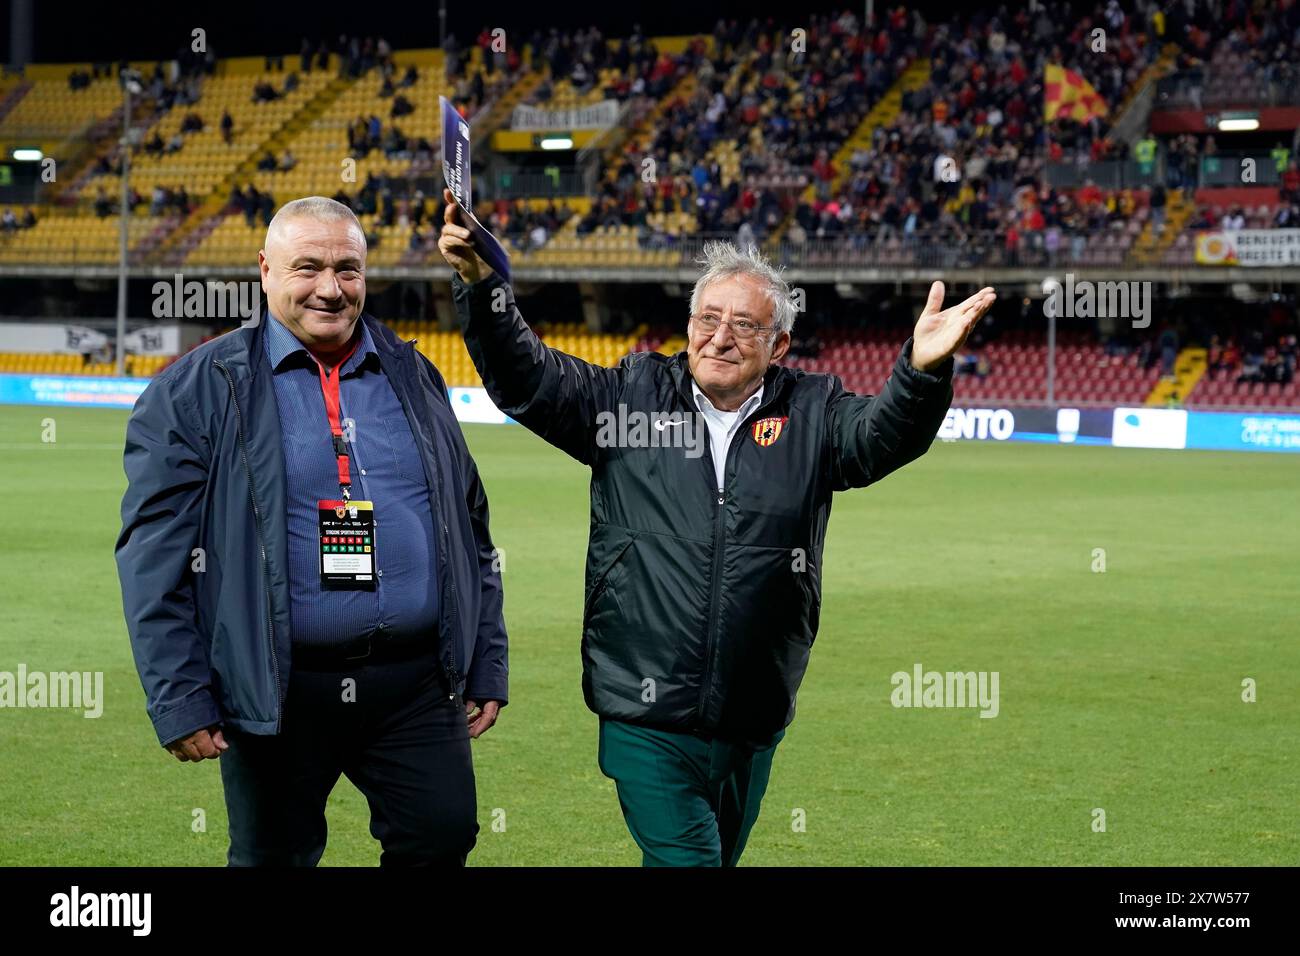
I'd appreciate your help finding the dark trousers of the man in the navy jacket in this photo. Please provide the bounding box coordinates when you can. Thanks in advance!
[218,654,478,866]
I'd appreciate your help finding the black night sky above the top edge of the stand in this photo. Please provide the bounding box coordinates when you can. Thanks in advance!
[0,0,915,62]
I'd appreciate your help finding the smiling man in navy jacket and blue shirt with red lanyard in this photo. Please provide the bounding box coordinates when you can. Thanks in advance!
[116,196,507,866]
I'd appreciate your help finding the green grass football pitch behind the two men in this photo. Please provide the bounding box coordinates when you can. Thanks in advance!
[0,407,1300,866]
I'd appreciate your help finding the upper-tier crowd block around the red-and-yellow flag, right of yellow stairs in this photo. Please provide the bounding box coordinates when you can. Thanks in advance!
[788,1,1164,261]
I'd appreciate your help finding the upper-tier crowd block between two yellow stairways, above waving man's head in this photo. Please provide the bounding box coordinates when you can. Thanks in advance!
[569,10,924,251]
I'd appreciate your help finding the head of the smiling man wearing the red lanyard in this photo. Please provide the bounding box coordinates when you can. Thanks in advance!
[257,196,365,364]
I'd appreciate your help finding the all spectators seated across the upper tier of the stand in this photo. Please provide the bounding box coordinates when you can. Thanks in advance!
[50,0,1300,274]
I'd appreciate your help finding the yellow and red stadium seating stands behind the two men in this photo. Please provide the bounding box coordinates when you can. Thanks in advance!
[0,0,1300,416]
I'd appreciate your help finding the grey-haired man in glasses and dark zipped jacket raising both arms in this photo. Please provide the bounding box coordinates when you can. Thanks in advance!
[438,195,995,865]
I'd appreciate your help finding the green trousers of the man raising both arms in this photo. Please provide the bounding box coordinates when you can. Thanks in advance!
[599,717,785,866]
